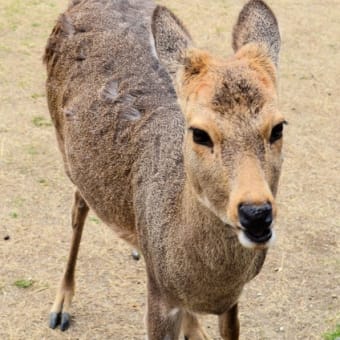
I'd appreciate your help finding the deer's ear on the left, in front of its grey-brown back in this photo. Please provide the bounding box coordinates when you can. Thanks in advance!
[151,6,192,79]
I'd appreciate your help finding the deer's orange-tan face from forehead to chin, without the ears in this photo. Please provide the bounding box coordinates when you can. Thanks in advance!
[178,47,285,247]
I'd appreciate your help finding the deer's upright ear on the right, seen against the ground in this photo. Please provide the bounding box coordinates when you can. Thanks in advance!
[233,0,281,67]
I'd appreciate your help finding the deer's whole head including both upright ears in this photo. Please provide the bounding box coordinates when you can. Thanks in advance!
[152,0,285,247]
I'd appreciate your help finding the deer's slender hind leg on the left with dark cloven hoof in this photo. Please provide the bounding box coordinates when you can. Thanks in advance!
[49,190,89,331]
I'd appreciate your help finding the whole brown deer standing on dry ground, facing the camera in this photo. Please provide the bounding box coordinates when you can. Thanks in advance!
[44,0,286,340]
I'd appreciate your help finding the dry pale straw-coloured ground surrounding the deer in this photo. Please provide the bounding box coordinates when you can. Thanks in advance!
[0,0,340,340]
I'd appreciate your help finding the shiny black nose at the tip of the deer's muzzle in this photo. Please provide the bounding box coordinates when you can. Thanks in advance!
[238,203,273,236]
